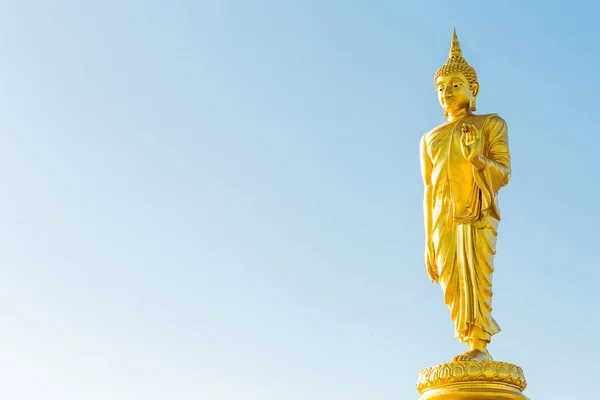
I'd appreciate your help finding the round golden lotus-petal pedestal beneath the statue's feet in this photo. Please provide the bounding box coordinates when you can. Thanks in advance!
[417,361,527,400]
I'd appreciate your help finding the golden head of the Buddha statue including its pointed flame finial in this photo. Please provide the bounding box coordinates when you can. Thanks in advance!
[434,29,479,118]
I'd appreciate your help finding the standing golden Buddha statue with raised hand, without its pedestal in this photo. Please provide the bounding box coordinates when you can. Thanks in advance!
[421,30,511,362]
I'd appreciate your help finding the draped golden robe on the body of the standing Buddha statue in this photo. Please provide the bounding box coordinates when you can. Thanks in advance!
[421,114,510,342]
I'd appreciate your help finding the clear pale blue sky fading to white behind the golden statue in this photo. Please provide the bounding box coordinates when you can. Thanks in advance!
[0,0,600,400]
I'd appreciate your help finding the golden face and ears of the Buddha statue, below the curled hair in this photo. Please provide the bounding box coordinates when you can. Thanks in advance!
[435,72,479,115]
